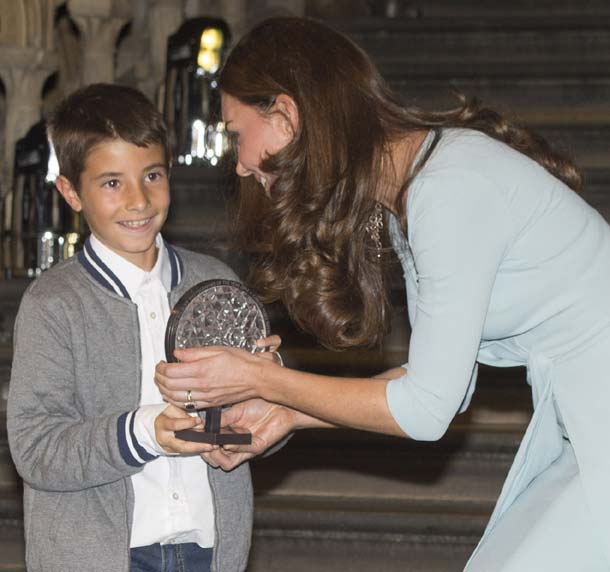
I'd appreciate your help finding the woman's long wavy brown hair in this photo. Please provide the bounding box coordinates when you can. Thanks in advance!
[220,18,581,349]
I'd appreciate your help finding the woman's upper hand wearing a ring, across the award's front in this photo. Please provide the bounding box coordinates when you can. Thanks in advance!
[155,336,281,409]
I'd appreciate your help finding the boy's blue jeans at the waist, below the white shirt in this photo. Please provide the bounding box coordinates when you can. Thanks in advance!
[131,542,214,572]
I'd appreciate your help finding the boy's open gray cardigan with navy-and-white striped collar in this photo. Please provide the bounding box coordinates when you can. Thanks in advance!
[7,244,252,572]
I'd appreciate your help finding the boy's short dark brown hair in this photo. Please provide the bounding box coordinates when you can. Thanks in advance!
[47,83,171,191]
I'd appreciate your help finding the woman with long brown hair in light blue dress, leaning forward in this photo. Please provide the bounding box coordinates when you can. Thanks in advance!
[156,15,610,572]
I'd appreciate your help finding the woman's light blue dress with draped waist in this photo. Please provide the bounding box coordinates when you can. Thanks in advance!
[387,129,610,572]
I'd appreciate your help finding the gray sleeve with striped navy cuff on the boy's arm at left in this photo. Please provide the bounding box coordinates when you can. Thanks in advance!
[7,288,151,492]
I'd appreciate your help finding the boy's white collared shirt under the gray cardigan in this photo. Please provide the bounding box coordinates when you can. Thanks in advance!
[90,234,214,548]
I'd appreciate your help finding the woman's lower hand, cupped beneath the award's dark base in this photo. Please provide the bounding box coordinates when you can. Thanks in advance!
[201,399,297,471]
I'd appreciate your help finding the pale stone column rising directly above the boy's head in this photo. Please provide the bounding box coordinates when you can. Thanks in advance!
[67,0,131,85]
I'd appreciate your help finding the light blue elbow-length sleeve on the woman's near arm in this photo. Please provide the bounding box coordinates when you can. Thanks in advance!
[387,169,512,441]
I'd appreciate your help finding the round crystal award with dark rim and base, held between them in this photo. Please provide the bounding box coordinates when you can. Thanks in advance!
[165,280,269,445]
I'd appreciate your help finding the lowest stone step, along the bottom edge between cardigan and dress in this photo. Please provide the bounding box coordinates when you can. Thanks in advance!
[248,497,488,572]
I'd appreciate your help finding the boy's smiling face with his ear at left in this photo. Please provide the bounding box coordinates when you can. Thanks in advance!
[55,139,170,271]
